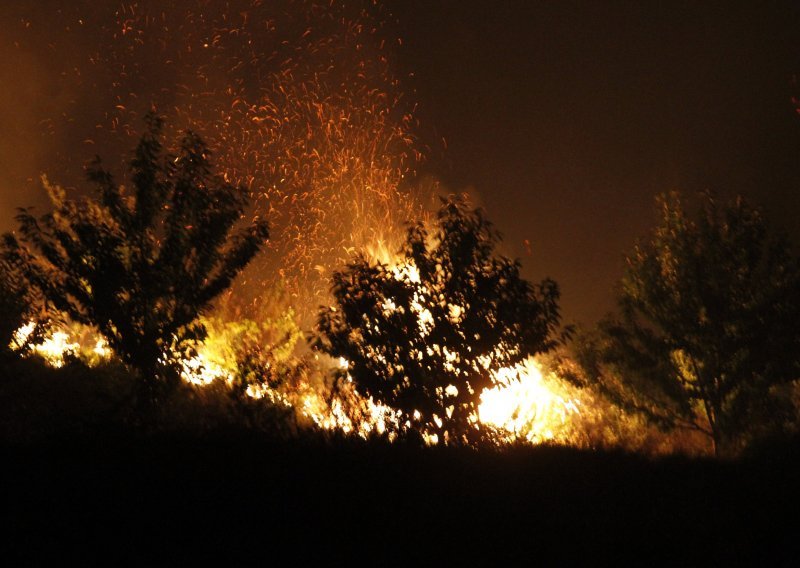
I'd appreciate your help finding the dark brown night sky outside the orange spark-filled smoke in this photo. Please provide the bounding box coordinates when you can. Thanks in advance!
[0,0,800,323]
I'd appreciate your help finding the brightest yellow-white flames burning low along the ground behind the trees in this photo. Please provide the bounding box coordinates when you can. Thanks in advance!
[11,322,580,444]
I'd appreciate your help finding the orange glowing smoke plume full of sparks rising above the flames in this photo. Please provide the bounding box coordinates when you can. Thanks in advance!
[9,0,432,325]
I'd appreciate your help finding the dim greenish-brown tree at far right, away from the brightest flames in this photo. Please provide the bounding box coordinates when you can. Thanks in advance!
[582,193,800,454]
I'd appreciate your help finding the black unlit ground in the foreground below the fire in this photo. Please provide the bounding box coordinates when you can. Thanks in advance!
[0,431,800,566]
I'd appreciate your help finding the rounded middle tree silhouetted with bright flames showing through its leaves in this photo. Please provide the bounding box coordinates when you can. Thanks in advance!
[314,195,560,443]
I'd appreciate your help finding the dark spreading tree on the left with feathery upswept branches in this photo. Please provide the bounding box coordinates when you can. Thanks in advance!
[4,113,268,396]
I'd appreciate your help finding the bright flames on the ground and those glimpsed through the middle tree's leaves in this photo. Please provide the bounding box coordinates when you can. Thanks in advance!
[12,246,580,444]
